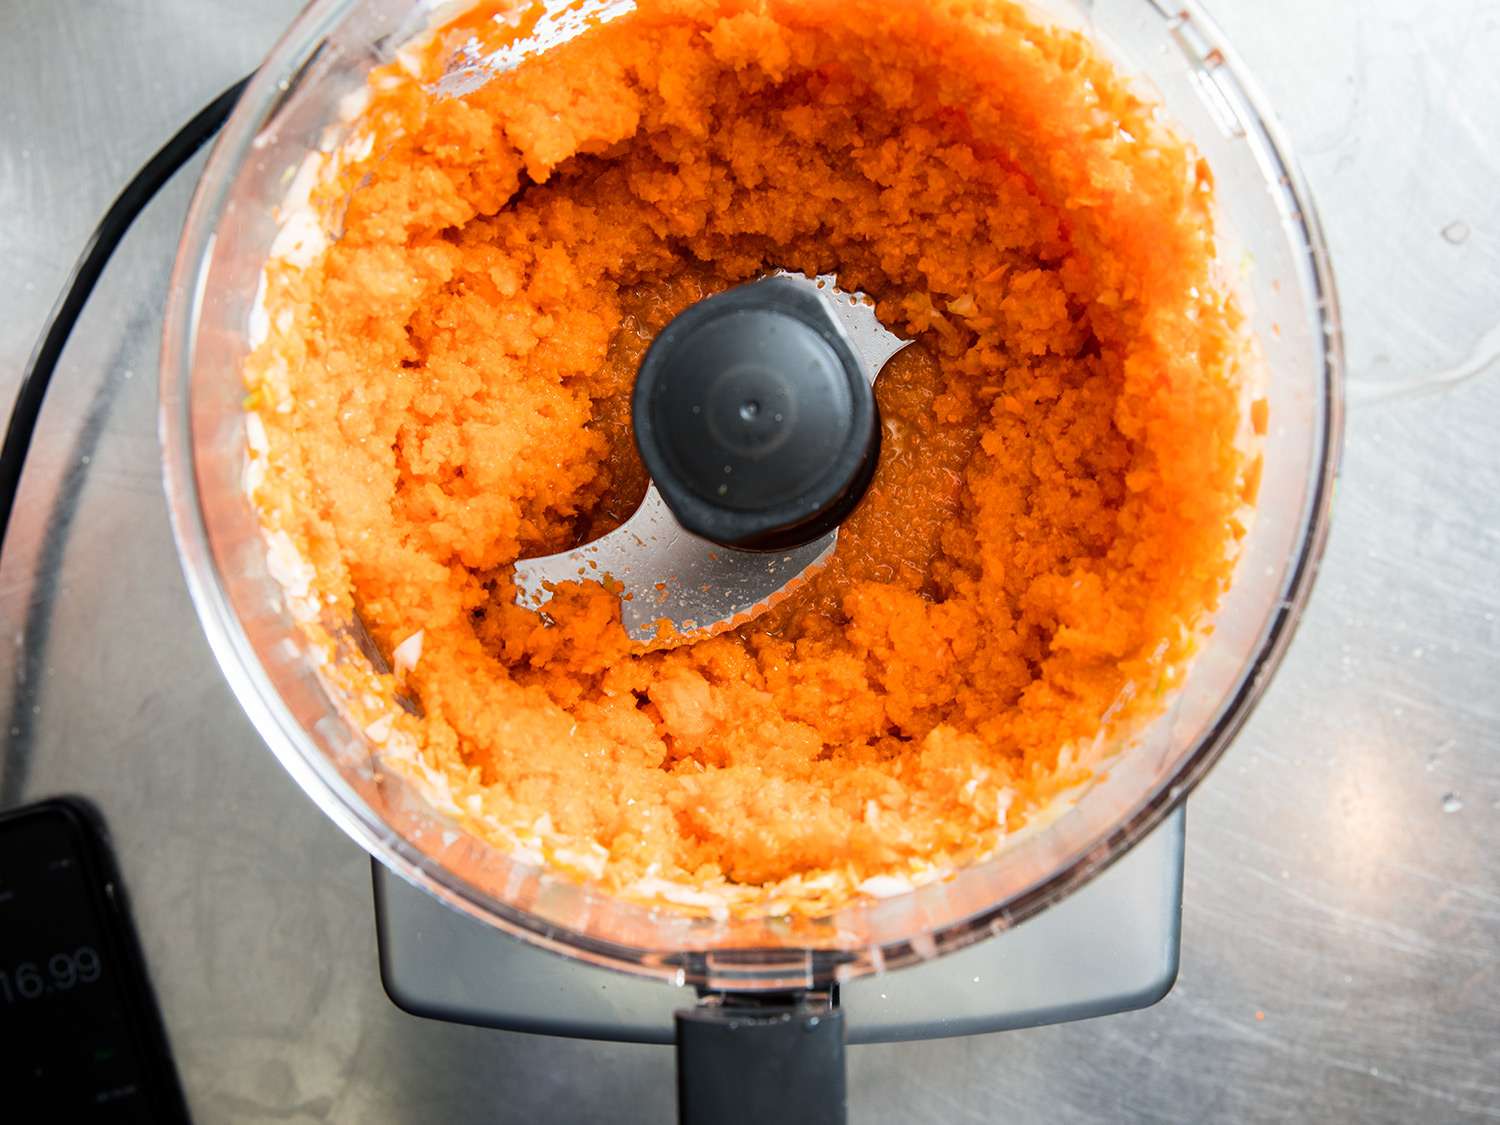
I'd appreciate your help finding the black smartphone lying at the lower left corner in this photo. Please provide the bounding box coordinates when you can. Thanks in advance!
[0,798,188,1125]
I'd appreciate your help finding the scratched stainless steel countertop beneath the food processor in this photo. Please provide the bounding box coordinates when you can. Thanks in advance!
[0,0,1500,1125]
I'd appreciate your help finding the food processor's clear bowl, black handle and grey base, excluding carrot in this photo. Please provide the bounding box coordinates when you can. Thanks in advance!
[161,0,1341,1121]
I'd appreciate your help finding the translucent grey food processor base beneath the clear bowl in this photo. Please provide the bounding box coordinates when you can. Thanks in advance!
[374,807,1184,1044]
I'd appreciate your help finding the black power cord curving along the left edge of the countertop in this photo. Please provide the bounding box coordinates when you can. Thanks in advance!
[0,77,251,552]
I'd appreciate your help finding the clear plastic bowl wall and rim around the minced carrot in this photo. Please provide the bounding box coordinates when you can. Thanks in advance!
[161,0,1343,992]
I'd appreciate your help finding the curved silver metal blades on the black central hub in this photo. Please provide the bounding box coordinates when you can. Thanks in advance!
[515,272,911,645]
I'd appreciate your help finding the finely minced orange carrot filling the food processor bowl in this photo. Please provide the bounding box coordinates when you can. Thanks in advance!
[249,0,1265,918]
